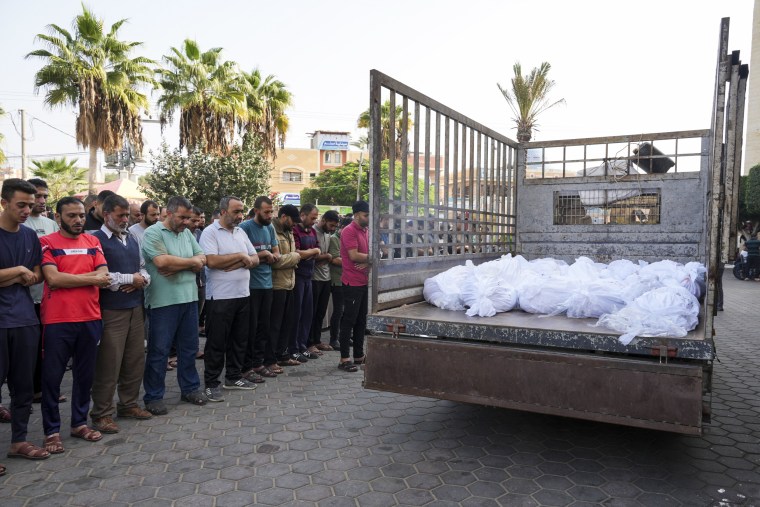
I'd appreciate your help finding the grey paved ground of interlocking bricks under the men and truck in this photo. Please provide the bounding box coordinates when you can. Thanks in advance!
[0,272,760,507]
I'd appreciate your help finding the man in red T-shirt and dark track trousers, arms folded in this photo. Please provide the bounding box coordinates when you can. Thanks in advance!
[40,197,111,454]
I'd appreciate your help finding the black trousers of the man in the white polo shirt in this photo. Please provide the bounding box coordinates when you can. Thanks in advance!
[203,297,250,387]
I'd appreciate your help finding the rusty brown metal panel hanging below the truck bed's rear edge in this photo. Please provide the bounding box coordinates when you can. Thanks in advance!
[364,336,704,435]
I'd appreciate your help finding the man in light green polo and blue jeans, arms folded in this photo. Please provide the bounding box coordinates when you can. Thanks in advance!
[142,196,207,415]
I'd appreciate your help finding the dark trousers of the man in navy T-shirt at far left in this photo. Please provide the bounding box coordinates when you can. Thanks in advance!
[0,326,40,444]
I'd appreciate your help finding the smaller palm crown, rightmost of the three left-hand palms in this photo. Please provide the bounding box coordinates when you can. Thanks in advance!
[240,69,293,160]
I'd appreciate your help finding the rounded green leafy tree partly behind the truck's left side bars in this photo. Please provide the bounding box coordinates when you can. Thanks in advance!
[301,160,433,206]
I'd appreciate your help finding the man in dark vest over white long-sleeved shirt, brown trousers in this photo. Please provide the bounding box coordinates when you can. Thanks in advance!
[90,195,151,433]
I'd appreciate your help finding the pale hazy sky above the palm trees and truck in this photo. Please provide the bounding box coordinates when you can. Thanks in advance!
[0,0,753,172]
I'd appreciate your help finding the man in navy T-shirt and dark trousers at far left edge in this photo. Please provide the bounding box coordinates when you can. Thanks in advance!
[0,178,50,475]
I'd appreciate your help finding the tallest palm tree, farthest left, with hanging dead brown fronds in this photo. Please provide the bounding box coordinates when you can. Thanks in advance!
[26,6,155,191]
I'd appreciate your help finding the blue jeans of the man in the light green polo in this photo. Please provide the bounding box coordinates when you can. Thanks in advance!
[143,301,201,403]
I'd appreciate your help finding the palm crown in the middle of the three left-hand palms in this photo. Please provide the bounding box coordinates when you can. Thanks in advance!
[158,39,248,154]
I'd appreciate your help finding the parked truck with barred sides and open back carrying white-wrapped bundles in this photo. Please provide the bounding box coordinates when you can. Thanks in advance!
[364,19,749,434]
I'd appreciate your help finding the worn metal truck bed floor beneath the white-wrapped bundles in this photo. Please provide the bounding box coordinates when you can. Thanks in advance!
[367,301,715,360]
